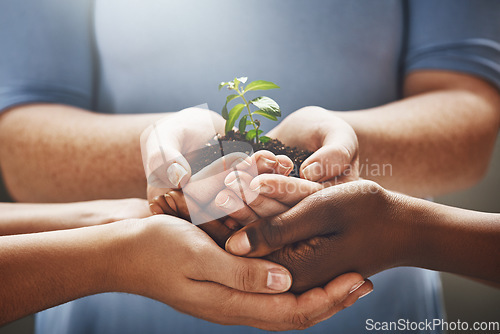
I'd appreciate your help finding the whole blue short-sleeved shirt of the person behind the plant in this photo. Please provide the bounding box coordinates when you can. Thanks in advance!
[0,0,500,334]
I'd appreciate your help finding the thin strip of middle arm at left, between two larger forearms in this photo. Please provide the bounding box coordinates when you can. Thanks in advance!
[0,198,151,236]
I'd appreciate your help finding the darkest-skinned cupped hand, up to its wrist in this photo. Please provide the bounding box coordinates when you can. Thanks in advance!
[226,181,402,291]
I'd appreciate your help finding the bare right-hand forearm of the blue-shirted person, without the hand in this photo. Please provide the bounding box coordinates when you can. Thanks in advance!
[336,74,500,196]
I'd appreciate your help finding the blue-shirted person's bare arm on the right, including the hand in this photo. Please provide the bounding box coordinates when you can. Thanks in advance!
[269,71,500,197]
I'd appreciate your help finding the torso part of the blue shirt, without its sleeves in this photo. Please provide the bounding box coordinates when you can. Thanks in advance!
[37,0,440,334]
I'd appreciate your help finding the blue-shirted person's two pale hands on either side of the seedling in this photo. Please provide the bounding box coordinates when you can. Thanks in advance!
[145,107,359,201]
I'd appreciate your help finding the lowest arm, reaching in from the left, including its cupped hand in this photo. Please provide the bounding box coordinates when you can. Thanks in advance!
[0,216,372,330]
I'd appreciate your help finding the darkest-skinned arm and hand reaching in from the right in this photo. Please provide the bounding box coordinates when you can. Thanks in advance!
[226,176,500,290]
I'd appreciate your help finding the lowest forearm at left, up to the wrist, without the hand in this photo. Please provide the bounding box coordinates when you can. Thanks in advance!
[0,222,140,325]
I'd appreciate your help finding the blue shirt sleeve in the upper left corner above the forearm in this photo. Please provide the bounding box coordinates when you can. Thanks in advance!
[0,0,94,111]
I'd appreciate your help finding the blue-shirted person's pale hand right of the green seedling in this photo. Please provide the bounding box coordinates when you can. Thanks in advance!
[268,106,359,183]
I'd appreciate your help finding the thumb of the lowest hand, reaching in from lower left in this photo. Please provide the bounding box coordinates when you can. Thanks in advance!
[200,248,292,293]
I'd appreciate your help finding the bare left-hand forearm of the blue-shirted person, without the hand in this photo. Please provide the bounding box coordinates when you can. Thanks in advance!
[0,104,165,202]
